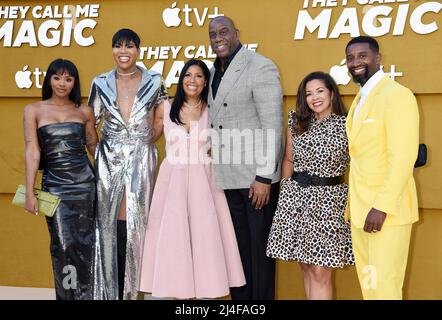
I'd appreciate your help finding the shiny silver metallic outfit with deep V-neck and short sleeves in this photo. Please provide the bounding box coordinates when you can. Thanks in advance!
[88,69,167,300]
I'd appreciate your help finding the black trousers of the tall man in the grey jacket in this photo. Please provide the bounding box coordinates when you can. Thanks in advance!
[224,183,279,300]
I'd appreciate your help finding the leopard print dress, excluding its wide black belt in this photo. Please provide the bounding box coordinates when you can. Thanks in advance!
[267,111,354,268]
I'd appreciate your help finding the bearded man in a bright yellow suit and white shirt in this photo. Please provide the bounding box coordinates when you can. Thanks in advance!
[345,36,419,299]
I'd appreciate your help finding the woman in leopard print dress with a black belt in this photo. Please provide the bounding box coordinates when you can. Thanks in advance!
[267,72,354,299]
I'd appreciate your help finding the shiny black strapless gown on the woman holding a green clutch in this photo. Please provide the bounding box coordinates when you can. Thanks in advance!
[37,122,95,300]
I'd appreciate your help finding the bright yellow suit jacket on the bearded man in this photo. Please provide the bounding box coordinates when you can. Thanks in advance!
[346,76,419,228]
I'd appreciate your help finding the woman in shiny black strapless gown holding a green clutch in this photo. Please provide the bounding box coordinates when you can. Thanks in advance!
[23,59,97,300]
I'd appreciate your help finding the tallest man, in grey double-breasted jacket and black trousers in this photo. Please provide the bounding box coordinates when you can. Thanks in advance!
[208,16,283,300]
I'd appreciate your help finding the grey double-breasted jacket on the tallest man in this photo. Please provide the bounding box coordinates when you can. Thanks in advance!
[209,47,283,189]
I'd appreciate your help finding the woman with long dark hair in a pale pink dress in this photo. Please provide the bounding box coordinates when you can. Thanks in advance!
[140,59,245,299]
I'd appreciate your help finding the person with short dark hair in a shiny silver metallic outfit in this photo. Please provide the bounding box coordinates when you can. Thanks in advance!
[88,29,167,300]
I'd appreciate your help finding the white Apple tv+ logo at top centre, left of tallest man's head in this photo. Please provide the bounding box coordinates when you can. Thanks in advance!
[163,2,224,28]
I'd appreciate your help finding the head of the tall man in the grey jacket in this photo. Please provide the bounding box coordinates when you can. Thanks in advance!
[209,16,239,63]
